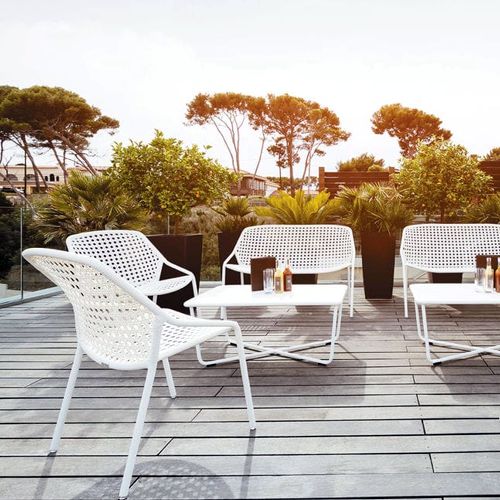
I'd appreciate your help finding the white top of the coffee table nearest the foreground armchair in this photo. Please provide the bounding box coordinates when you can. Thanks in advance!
[184,285,347,307]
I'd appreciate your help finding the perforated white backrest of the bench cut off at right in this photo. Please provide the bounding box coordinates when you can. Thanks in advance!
[401,224,500,272]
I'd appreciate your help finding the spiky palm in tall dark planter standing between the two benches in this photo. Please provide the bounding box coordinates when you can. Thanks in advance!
[335,184,413,299]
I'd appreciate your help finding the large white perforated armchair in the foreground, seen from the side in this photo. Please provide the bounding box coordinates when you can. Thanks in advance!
[23,248,255,499]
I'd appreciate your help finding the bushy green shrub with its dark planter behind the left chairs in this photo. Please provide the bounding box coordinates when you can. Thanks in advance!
[106,130,235,310]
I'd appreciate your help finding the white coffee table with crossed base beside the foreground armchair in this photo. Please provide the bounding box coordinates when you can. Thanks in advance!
[184,285,347,366]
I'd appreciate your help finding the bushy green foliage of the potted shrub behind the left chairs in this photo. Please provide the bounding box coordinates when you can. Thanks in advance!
[106,130,236,232]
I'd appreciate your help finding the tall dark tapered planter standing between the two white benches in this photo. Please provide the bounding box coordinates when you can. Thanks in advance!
[361,232,396,299]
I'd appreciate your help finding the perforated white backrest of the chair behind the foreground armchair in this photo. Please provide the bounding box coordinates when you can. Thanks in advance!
[66,230,162,285]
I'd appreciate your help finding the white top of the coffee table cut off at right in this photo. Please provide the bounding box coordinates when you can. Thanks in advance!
[410,283,500,305]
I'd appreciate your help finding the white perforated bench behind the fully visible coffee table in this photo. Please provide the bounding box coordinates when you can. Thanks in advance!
[222,224,356,316]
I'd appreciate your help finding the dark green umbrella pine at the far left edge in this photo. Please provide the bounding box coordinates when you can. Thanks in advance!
[0,85,119,179]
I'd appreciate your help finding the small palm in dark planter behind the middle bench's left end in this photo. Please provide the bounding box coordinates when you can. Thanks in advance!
[214,196,260,285]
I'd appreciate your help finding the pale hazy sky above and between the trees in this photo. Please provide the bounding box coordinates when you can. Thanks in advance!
[0,0,500,175]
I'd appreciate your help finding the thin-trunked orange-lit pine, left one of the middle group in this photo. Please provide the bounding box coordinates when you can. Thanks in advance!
[186,92,266,179]
